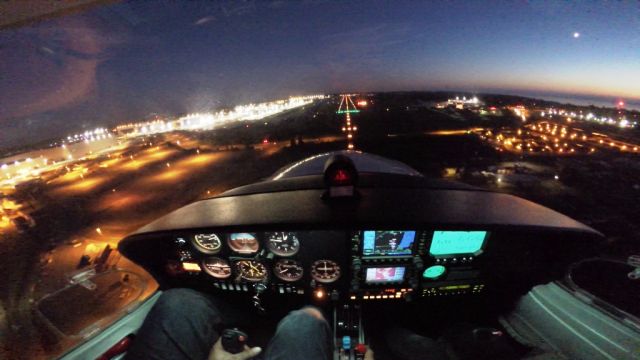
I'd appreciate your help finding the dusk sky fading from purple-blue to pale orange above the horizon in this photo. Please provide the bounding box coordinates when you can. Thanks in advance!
[0,1,640,147]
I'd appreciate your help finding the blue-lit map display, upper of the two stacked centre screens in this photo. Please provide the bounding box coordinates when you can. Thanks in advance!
[362,230,416,256]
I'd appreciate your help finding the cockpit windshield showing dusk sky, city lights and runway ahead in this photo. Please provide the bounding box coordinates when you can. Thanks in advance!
[0,1,640,358]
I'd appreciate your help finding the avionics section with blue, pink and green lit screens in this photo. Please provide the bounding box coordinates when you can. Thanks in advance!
[349,230,488,300]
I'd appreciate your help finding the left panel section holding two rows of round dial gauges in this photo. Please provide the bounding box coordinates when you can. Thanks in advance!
[173,230,349,294]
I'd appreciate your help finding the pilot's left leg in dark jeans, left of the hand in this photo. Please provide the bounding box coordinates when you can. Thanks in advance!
[127,289,222,360]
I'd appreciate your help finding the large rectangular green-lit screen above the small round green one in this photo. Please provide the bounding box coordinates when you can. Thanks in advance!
[429,231,487,256]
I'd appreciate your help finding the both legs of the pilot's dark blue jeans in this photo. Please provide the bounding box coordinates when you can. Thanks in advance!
[126,289,333,360]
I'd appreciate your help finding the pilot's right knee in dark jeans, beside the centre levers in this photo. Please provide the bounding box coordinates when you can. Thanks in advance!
[265,307,333,360]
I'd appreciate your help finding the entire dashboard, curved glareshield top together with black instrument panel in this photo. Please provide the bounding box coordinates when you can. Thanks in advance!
[118,174,605,301]
